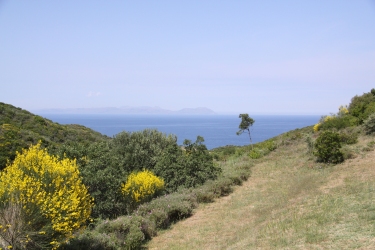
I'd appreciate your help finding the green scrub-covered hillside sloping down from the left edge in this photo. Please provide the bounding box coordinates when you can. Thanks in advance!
[0,102,109,169]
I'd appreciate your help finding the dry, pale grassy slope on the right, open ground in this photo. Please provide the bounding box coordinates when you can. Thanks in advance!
[148,133,375,250]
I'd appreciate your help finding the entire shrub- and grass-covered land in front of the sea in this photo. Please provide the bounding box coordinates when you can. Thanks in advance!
[0,90,375,250]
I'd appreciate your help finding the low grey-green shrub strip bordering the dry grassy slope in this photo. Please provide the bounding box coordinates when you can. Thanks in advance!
[61,156,251,250]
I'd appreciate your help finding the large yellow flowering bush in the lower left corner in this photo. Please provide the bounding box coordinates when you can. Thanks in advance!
[0,143,93,249]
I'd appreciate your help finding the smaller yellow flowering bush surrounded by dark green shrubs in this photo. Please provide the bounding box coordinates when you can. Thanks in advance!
[122,170,164,206]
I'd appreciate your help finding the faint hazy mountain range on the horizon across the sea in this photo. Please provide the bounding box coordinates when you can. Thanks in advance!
[33,106,216,115]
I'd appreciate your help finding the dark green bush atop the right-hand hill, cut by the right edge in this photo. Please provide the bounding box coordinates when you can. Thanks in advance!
[348,89,375,124]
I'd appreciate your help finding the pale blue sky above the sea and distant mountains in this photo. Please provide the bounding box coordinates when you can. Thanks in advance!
[0,0,375,115]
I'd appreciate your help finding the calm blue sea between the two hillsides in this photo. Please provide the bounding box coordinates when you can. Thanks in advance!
[41,114,320,149]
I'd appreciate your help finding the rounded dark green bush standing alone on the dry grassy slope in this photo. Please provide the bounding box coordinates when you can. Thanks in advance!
[314,131,344,164]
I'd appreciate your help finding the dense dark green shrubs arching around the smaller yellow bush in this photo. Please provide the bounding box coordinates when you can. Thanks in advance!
[59,130,220,218]
